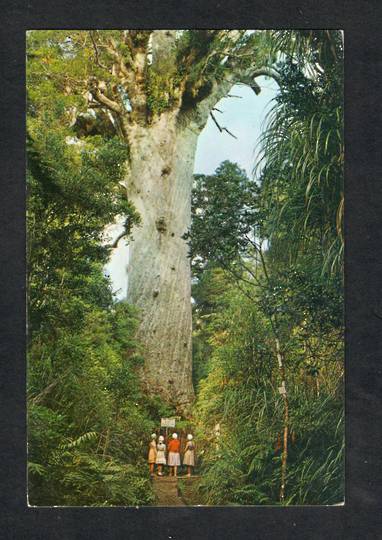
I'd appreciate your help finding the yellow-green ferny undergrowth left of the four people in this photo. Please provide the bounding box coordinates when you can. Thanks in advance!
[28,292,157,505]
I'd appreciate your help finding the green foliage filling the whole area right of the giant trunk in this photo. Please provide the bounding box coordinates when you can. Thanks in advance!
[187,31,344,505]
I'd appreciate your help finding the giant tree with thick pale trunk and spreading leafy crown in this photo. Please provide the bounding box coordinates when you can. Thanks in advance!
[28,30,277,411]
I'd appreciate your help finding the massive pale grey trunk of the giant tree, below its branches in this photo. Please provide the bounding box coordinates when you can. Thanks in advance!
[127,111,198,412]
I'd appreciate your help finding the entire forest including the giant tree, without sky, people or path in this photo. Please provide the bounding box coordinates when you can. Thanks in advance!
[27,30,344,506]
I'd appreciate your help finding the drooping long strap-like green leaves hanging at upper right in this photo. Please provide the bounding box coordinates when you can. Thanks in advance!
[257,31,344,274]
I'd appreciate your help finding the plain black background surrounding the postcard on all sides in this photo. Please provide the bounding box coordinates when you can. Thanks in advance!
[0,0,382,540]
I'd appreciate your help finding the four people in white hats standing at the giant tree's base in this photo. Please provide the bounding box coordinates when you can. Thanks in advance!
[148,433,195,476]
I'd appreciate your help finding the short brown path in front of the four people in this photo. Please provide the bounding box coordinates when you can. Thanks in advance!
[152,476,199,506]
